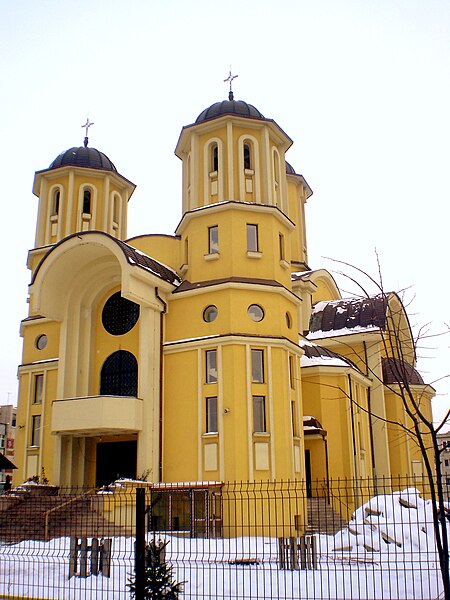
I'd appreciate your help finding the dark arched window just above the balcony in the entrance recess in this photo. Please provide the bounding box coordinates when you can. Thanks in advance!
[100,350,138,397]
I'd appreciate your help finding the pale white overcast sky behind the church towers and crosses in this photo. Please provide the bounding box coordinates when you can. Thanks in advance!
[0,0,450,428]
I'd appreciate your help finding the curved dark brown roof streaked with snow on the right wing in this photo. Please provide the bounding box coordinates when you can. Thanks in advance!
[308,294,388,339]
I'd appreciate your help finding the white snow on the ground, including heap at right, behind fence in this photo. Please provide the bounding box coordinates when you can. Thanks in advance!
[0,489,442,600]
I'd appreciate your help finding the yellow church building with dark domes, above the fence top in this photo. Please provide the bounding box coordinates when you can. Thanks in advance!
[15,94,433,528]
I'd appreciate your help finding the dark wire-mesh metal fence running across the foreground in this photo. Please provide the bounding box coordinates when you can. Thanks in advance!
[0,478,450,600]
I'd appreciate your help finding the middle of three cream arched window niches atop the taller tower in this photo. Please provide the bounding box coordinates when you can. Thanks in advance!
[238,134,261,202]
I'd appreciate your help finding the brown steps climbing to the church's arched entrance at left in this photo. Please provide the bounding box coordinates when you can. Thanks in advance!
[0,491,131,543]
